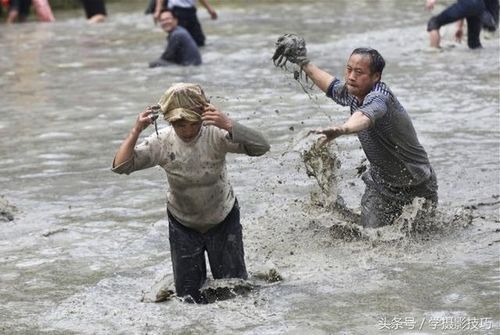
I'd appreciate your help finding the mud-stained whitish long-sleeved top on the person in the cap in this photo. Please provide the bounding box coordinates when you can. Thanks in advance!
[112,122,269,232]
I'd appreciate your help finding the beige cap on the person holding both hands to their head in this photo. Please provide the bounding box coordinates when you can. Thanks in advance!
[158,83,209,123]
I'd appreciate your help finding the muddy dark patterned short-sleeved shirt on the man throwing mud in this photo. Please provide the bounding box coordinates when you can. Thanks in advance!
[327,79,434,192]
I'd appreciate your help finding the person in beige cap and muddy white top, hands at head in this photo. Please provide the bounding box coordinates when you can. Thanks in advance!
[113,83,270,303]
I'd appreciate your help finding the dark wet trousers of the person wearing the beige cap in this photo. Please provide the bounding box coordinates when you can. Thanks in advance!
[167,202,248,303]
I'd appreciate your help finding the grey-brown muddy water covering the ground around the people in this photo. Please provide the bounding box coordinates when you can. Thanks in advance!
[0,0,500,334]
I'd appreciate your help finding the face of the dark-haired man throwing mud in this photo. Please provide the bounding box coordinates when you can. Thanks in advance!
[345,54,380,102]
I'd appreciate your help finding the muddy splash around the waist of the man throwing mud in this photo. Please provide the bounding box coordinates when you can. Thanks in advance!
[301,141,473,244]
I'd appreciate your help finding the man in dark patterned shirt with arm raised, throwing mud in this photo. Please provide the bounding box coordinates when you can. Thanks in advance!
[273,34,438,227]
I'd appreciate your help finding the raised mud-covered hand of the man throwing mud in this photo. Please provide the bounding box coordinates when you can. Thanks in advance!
[272,34,309,67]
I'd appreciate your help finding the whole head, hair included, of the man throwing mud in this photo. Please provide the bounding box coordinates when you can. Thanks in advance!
[345,48,385,101]
